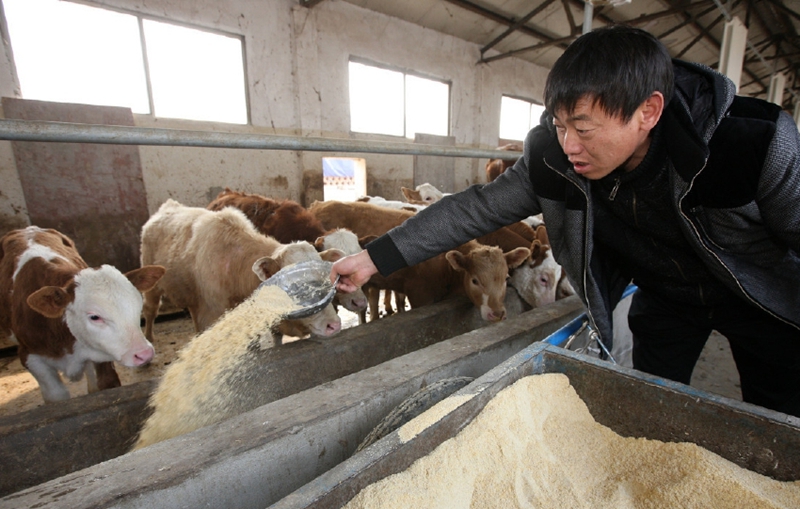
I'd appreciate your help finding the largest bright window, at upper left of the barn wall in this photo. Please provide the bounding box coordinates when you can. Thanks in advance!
[3,0,248,124]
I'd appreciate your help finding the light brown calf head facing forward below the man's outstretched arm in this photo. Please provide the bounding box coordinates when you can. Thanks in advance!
[445,246,530,322]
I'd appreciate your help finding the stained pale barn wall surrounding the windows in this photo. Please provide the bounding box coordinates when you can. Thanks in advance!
[0,0,547,234]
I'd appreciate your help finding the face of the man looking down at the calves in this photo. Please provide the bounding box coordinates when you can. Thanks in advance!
[553,98,650,180]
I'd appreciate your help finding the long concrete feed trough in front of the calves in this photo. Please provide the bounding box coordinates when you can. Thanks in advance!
[0,297,581,508]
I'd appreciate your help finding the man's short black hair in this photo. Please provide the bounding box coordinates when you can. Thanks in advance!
[544,25,674,122]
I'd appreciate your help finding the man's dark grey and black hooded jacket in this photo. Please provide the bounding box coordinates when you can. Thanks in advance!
[367,60,800,343]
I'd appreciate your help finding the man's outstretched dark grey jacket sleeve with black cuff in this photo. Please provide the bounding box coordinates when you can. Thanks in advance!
[367,137,541,276]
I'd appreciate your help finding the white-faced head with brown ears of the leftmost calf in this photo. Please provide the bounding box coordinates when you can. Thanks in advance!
[27,265,165,367]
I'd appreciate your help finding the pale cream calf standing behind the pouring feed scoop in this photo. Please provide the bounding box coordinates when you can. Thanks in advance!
[141,199,343,340]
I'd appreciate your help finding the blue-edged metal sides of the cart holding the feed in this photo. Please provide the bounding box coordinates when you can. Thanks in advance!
[269,343,800,509]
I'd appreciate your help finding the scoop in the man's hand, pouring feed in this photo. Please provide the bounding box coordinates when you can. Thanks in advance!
[259,260,339,320]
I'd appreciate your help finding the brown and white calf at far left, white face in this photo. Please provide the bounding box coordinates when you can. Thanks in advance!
[0,226,164,403]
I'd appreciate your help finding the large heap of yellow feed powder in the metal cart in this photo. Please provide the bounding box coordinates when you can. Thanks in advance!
[345,374,800,509]
